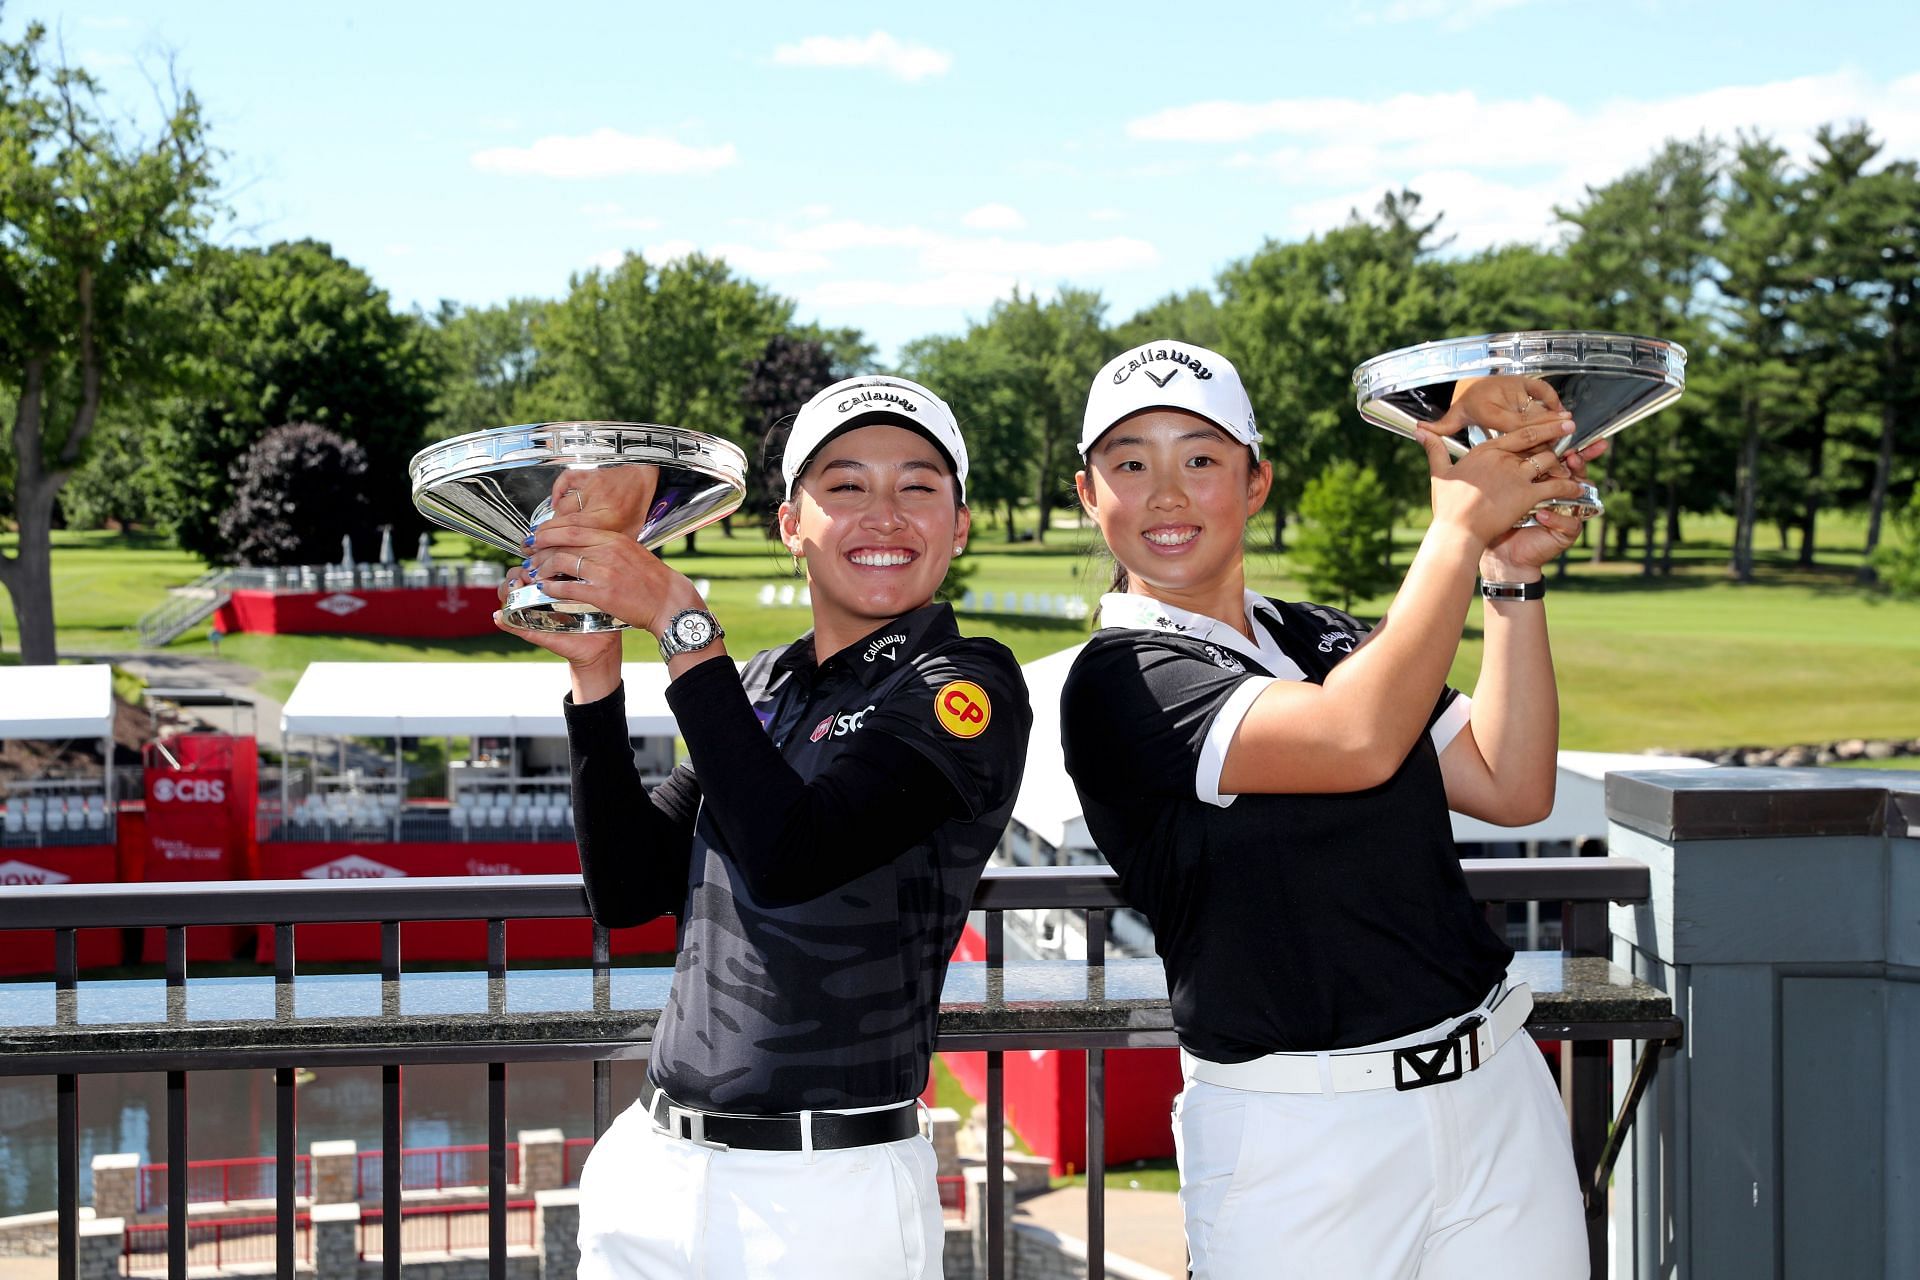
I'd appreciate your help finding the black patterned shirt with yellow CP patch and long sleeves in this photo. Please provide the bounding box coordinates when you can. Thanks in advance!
[568,604,1033,1113]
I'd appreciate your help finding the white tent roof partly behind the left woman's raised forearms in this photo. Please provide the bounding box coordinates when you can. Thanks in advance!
[280,662,674,737]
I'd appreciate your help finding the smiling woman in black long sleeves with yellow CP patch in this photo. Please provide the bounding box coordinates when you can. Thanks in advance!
[501,378,1031,1280]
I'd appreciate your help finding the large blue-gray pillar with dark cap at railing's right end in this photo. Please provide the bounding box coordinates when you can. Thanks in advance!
[1607,768,1920,1280]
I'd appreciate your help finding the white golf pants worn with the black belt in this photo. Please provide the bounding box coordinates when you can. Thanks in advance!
[578,1103,945,1280]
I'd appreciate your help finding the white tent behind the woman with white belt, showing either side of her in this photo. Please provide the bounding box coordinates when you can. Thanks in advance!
[1014,645,1711,848]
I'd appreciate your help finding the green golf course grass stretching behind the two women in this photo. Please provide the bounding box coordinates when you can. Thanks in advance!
[0,516,1920,750]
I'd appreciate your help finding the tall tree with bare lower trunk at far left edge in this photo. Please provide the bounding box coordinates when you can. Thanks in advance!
[0,23,213,664]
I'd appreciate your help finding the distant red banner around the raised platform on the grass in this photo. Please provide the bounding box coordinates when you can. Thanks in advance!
[215,587,499,639]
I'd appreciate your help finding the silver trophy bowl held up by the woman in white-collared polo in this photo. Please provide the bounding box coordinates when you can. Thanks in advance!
[1354,330,1686,518]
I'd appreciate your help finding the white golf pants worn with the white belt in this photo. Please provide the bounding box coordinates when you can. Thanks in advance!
[1173,997,1588,1280]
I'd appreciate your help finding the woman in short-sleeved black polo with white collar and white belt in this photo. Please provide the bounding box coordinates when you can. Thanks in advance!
[1062,342,1603,1280]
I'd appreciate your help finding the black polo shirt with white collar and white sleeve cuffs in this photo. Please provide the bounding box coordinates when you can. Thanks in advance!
[1062,593,1513,1063]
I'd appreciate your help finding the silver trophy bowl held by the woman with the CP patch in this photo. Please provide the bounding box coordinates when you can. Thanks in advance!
[407,422,747,631]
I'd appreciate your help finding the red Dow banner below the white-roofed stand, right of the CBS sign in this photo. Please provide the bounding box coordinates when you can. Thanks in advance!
[257,841,674,963]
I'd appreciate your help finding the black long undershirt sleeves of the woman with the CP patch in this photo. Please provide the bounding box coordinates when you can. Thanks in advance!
[568,660,968,923]
